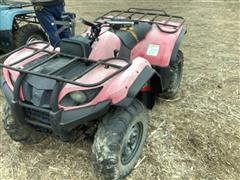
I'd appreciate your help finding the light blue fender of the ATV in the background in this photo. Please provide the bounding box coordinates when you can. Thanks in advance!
[0,9,34,31]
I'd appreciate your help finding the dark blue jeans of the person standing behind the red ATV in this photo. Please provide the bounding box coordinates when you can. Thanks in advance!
[35,4,71,47]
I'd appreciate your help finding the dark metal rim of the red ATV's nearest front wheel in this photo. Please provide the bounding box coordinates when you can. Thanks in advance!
[121,122,143,165]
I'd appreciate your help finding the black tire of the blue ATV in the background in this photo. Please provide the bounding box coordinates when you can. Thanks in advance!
[14,24,48,48]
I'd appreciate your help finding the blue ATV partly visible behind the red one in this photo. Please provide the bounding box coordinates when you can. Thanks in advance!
[0,0,48,52]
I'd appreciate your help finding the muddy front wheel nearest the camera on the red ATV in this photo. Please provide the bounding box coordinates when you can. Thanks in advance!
[92,100,149,180]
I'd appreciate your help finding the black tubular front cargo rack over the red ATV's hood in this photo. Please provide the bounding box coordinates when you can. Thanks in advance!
[0,41,131,87]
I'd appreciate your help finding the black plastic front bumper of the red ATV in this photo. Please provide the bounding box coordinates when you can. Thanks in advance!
[1,78,111,136]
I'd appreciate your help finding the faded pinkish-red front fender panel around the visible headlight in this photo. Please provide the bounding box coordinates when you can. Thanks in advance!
[59,57,155,111]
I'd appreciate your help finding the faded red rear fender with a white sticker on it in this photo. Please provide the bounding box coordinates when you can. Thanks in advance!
[131,25,186,67]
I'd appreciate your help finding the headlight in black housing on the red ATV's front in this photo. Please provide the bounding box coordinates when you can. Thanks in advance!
[60,87,102,106]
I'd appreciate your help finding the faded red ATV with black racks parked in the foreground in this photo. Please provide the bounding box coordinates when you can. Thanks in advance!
[1,8,186,179]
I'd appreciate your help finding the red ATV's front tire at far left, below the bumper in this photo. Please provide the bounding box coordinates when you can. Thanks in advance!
[2,103,46,144]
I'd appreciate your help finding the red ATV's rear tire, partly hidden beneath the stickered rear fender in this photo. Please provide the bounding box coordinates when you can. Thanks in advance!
[161,50,184,99]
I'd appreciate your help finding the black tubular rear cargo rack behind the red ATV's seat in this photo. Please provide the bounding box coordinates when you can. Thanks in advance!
[95,8,185,33]
